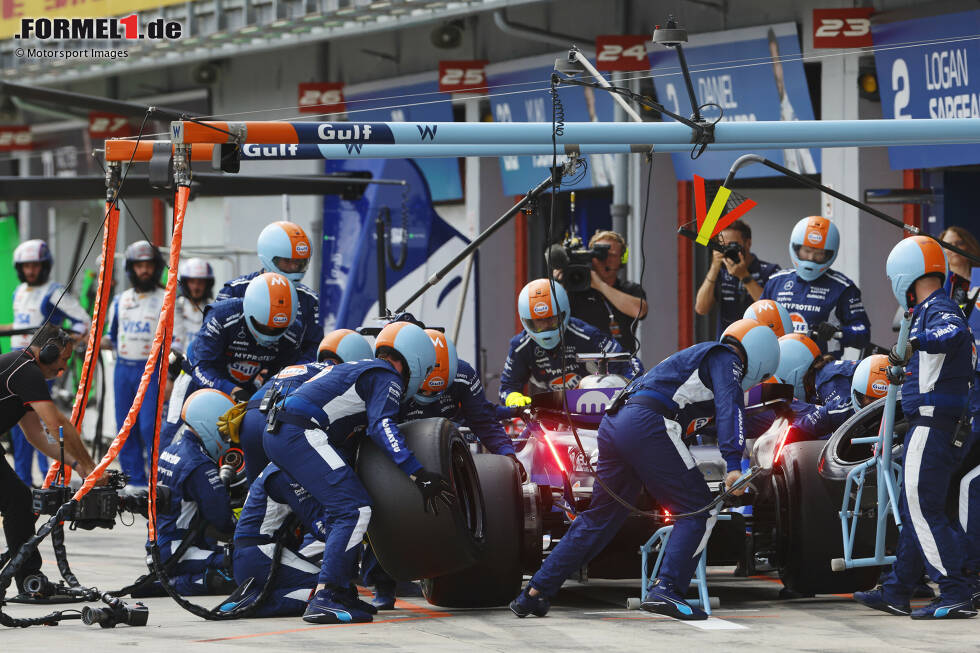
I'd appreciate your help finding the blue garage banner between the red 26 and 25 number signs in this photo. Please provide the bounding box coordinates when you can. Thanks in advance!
[345,75,463,202]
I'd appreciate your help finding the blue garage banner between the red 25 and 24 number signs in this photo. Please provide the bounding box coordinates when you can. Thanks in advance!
[487,52,614,195]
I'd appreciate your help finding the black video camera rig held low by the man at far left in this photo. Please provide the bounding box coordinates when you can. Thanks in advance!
[33,470,170,530]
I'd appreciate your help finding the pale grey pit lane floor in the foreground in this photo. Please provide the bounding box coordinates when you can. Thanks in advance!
[0,517,980,653]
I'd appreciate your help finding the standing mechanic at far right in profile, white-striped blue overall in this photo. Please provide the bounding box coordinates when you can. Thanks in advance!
[854,236,977,619]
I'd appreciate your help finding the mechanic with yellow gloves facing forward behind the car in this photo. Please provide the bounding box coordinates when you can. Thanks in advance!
[500,279,643,408]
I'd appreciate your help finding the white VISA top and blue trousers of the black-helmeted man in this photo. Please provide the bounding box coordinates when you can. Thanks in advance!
[106,288,164,485]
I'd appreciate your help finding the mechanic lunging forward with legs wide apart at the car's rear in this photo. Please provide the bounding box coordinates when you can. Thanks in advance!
[510,318,779,620]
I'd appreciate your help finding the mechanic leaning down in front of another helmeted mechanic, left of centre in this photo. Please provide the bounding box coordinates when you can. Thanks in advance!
[160,272,300,441]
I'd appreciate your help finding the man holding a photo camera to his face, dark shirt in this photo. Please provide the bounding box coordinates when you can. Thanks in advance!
[694,220,779,336]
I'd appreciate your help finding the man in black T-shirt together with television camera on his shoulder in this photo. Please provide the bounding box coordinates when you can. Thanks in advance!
[547,231,647,353]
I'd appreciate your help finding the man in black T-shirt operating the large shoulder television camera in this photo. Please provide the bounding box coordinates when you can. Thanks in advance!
[552,231,647,352]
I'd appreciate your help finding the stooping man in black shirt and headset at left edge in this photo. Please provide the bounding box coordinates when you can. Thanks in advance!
[0,324,95,591]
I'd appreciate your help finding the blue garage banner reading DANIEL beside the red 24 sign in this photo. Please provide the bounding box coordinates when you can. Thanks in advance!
[650,23,820,180]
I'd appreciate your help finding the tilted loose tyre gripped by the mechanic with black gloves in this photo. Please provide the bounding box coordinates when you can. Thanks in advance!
[357,418,486,581]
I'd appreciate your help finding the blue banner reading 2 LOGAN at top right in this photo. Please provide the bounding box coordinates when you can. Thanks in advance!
[871,9,980,170]
